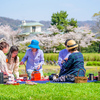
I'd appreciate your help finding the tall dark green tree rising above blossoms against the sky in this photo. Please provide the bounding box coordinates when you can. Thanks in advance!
[51,11,77,31]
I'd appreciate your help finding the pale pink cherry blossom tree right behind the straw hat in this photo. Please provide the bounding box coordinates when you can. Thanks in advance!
[66,26,99,51]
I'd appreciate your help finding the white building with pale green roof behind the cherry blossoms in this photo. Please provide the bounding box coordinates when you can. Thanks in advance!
[18,21,43,41]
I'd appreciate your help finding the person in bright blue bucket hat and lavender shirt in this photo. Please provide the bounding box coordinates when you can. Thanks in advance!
[20,40,44,79]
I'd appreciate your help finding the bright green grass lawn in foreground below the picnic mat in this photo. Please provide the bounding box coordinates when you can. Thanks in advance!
[0,83,100,100]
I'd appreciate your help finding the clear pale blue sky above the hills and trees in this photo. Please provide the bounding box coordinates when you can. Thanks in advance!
[0,0,100,21]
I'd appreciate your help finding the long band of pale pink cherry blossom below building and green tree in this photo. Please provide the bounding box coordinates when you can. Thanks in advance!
[18,26,99,51]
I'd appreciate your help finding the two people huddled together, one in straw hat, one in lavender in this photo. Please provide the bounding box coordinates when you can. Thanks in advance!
[54,39,86,82]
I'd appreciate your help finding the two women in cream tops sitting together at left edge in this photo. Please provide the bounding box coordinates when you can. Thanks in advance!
[0,42,19,80]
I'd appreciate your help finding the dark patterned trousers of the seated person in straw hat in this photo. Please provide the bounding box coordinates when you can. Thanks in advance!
[53,74,75,82]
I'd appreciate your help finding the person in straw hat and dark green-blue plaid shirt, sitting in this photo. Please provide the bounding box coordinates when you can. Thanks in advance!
[54,40,85,81]
